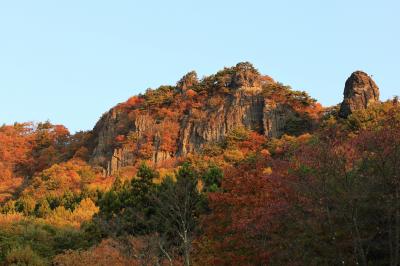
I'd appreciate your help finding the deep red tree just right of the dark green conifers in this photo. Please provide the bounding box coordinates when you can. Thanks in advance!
[198,158,290,265]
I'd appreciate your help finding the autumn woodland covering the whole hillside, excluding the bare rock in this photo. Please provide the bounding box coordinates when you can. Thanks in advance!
[0,63,400,266]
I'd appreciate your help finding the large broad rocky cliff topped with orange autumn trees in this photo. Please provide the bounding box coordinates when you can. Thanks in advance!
[87,63,320,175]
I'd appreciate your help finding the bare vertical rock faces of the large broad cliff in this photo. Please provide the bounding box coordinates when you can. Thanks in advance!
[91,87,294,175]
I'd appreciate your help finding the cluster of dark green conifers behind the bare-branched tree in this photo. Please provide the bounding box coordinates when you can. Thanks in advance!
[93,163,205,262]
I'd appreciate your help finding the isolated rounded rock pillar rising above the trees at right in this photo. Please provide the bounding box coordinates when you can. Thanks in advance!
[339,71,379,118]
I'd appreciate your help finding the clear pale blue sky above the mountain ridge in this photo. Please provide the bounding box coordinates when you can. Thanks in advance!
[0,0,400,132]
